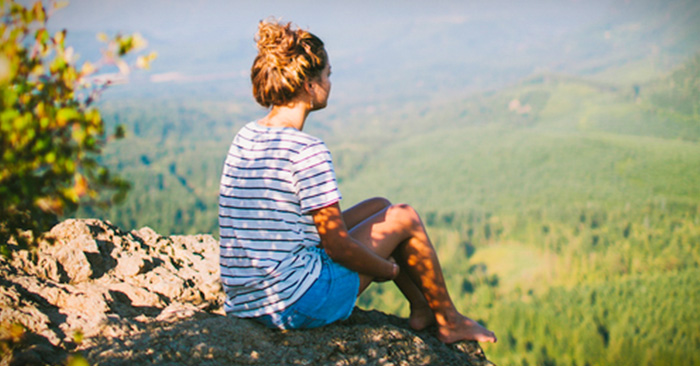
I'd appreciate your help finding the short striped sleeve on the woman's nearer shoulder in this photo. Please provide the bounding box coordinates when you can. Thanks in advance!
[292,141,342,214]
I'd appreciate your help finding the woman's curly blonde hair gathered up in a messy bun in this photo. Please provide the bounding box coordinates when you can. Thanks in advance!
[250,19,328,107]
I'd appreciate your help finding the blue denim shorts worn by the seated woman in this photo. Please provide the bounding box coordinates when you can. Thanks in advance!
[252,249,360,329]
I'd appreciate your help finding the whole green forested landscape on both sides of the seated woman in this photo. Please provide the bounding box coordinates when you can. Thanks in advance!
[72,52,700,365]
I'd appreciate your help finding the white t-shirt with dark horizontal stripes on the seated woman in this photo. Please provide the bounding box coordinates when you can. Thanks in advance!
[219,122,341,317]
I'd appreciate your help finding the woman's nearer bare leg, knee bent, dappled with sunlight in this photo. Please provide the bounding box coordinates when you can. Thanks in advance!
[350,205,496,343]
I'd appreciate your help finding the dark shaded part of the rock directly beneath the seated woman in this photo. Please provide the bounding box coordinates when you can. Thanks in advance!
[81,308,492,366]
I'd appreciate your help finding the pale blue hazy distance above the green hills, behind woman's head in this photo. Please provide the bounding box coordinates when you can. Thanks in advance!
[52,0,700,104]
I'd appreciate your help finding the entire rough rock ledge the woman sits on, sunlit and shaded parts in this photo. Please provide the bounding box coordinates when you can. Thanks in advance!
[0,220,492,366]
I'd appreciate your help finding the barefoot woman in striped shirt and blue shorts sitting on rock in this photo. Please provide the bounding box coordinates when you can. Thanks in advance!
[219,21,496,343]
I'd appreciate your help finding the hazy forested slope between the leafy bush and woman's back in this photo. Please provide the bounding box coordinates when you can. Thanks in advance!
[78,100,259,234]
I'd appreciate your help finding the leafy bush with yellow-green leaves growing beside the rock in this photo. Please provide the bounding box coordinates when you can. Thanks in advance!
[0,1,155,255]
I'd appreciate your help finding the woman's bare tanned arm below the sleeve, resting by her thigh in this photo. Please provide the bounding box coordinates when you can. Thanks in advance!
[312,202,399,281]
